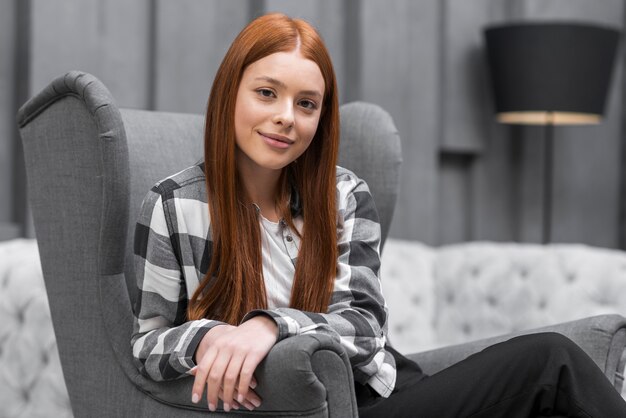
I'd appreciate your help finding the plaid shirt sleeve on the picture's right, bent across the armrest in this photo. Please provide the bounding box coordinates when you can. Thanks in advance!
[244,176,395,396]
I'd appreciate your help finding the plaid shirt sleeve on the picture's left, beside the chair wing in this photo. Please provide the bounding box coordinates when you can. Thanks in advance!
[131,185,222,381]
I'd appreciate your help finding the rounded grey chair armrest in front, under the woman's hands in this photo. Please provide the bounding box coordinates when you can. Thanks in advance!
[142,334,358,418]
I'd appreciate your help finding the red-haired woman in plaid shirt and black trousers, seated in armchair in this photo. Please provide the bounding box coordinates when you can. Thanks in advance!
[132,14,626,416]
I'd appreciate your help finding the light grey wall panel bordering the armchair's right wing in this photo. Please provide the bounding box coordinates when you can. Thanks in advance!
[361,0,440,243]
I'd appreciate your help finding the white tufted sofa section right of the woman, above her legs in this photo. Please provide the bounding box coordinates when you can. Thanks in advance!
[381,238,626,395]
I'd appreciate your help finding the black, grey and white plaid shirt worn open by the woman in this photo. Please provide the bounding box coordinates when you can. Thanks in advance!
[131,165,396,397]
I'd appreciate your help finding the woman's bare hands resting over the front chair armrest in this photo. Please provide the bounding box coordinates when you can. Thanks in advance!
[192,315,278,411]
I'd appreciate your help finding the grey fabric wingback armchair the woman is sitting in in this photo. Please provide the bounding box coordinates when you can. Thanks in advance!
[18,72,626,418]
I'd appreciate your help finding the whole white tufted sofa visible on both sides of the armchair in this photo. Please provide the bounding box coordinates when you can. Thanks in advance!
[0,238,626,418]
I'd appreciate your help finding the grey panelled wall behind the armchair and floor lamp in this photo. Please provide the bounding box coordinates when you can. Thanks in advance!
[0,0,626,248]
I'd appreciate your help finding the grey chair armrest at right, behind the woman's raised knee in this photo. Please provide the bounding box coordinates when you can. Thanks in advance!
[408,315,626,392]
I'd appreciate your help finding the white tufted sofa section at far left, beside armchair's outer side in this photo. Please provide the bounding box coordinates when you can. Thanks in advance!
[0,239,72,418]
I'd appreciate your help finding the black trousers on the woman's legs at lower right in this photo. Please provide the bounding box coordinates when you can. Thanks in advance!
[355,333,626,418]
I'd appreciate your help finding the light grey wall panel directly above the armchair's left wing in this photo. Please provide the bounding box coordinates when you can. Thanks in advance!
[30,0,151,108]
